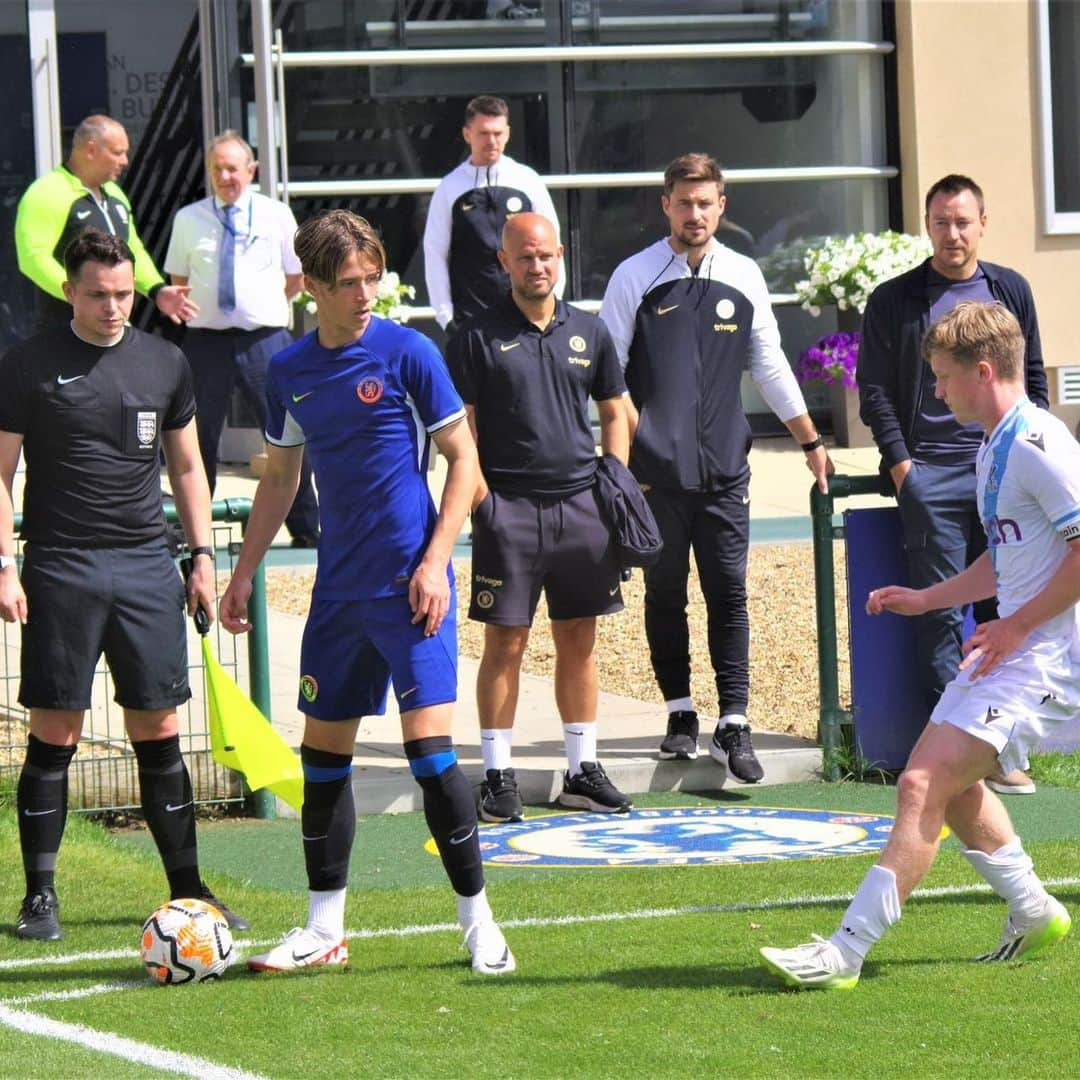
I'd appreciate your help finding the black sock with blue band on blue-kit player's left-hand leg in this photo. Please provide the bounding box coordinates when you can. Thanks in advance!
[300,744,356,892]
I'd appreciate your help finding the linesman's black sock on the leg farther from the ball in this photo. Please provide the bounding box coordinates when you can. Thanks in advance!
[15,735,76,894]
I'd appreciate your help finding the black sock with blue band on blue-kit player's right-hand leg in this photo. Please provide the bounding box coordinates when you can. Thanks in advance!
[405,735,484,896]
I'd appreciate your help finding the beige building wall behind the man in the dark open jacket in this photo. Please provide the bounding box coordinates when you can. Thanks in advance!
[896,0,1080,427]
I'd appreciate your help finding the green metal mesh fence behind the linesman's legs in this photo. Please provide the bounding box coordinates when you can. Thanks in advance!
[0,499,274,816]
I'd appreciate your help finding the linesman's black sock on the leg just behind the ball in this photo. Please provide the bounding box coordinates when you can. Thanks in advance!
[132,735,202,900]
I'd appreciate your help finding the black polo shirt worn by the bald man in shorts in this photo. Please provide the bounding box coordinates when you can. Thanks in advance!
[446,294,624,496]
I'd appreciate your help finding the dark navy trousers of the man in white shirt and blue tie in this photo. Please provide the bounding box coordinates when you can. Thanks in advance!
[184,327,319,537]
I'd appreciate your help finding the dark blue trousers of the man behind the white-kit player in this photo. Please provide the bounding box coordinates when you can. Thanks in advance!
[896,462,997,710]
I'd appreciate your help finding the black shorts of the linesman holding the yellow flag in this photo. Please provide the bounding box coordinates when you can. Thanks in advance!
[18,542,191,711]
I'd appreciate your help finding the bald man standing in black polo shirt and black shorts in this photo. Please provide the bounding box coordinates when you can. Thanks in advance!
[447,214,631,821]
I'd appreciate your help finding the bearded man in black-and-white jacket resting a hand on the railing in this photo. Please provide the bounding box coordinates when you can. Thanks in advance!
[600,153,832,783]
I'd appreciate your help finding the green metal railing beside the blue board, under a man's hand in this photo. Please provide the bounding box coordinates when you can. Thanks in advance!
[810,475,895,780]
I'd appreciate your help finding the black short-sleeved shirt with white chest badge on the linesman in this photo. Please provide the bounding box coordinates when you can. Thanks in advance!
[0,327,195,548]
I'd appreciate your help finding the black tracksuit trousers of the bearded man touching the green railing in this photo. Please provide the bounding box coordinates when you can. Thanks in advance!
[645,486,750,714]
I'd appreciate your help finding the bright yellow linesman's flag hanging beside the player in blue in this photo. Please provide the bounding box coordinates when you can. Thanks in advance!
[202,635,303,810]
